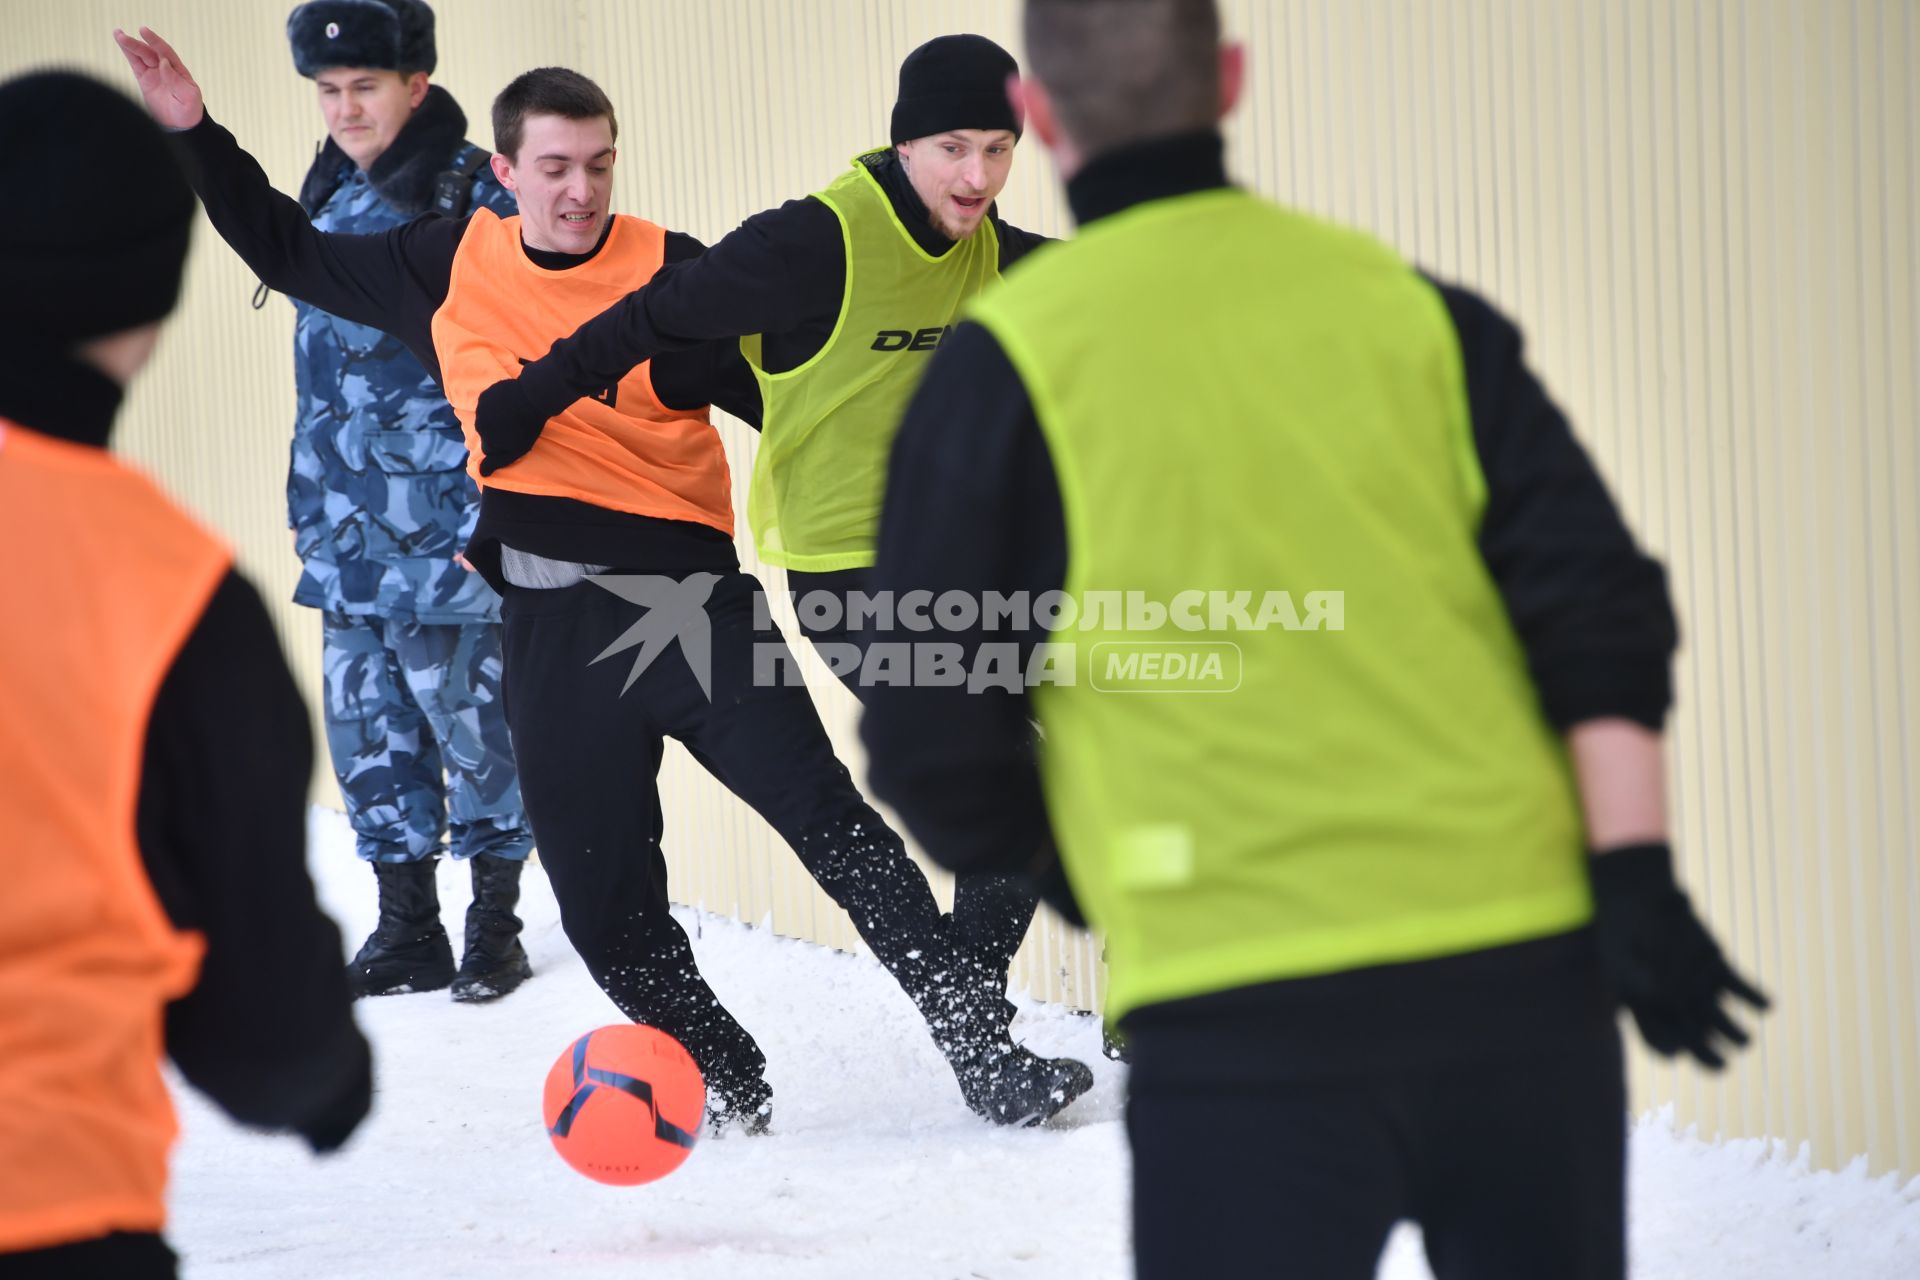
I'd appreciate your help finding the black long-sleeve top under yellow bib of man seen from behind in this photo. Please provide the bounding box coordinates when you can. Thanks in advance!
[862,134,1676,905]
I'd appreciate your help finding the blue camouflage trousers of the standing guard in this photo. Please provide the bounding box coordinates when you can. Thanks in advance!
[323,610,534,862]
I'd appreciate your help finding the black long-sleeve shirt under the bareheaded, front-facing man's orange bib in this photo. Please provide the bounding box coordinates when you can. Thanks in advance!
[175,115,760,589]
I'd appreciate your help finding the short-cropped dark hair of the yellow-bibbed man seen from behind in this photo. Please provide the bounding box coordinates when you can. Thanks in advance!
[1025,0,1219,155]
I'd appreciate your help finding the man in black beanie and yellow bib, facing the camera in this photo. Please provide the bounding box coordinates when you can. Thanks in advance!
[474,35,1092,1109]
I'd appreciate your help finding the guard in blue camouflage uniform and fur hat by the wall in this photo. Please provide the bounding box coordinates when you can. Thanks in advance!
[286,0,532,1000]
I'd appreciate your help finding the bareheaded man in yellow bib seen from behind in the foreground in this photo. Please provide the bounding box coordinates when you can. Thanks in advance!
[864,0,1763,1280]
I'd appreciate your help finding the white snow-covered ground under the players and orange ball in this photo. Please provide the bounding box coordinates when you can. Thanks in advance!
[171,810,1920,1280]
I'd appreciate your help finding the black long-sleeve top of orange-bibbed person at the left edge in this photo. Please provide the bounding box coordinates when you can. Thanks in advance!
[0,359,371,1140]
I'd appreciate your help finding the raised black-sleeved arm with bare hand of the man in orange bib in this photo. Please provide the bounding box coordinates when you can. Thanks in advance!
[113,27,453,355]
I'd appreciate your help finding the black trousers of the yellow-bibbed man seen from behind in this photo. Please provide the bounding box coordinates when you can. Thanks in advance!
[1125,936,1626,1280]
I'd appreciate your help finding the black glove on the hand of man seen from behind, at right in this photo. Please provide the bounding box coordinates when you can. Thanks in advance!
[1588,844,1768,1071]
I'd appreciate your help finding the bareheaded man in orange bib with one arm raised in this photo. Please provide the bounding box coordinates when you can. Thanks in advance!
[117,31,1082,1130]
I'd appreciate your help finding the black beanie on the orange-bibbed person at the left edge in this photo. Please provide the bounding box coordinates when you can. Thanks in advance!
[0,71,194,351]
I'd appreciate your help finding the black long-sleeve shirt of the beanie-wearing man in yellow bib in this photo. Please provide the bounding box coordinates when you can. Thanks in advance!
[503,150,1046,418]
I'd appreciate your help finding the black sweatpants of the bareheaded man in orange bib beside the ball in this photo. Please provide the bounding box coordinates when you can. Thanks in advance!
[503,572,952,1098]
